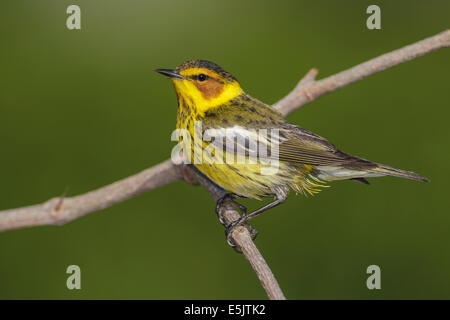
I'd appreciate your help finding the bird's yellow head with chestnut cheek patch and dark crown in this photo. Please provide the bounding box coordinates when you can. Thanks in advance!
[155,60,242,113]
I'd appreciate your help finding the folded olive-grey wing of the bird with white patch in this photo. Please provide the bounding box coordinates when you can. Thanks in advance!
[200,97,369,166]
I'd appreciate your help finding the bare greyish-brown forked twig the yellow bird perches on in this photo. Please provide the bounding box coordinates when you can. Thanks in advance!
[0,30,450,299]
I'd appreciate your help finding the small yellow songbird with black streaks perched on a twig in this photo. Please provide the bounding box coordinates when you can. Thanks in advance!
[156,60,428,243]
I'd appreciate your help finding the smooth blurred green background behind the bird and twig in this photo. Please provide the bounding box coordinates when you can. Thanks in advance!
[0,0,450,299]
